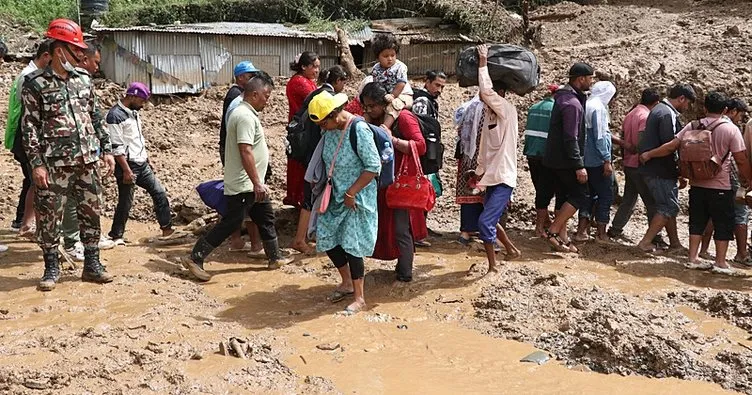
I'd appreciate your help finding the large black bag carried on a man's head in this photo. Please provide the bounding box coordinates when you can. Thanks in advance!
[457,44,540,95]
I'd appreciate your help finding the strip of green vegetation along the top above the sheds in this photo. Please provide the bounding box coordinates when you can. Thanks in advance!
[0,0,580,40]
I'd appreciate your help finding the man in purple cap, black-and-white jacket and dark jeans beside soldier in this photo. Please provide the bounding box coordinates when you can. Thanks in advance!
[107,82,184,245]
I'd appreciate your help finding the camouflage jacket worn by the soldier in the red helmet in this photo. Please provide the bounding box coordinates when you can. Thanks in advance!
[21,67,112,168]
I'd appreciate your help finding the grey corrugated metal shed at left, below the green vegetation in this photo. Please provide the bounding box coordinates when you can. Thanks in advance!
[94,22,339,94]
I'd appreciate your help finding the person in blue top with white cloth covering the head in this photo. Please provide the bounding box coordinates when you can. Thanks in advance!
[574,81,616,242]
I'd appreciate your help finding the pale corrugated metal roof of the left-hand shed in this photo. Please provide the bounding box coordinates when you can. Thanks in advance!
[94,22,334,40]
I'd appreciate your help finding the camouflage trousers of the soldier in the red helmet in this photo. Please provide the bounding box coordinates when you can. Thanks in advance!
[34,162,102,251]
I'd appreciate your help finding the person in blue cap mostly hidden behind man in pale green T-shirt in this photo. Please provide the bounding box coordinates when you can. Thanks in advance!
[219,60,262,258]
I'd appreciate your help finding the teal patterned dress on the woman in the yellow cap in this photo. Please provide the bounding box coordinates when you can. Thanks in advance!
[316,122,381,257]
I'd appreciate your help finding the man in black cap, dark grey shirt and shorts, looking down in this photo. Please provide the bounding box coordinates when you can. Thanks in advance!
[637,84,704,252]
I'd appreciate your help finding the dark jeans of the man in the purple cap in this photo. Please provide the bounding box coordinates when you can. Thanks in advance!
[109,162,172,239]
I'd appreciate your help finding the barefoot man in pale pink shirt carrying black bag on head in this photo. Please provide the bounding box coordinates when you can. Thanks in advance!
[475,45,520,273]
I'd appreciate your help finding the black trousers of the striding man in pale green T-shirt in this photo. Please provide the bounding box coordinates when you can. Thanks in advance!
[205,192,277,248]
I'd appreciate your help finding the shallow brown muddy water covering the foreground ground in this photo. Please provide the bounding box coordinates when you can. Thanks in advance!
[0,223,745,394]
